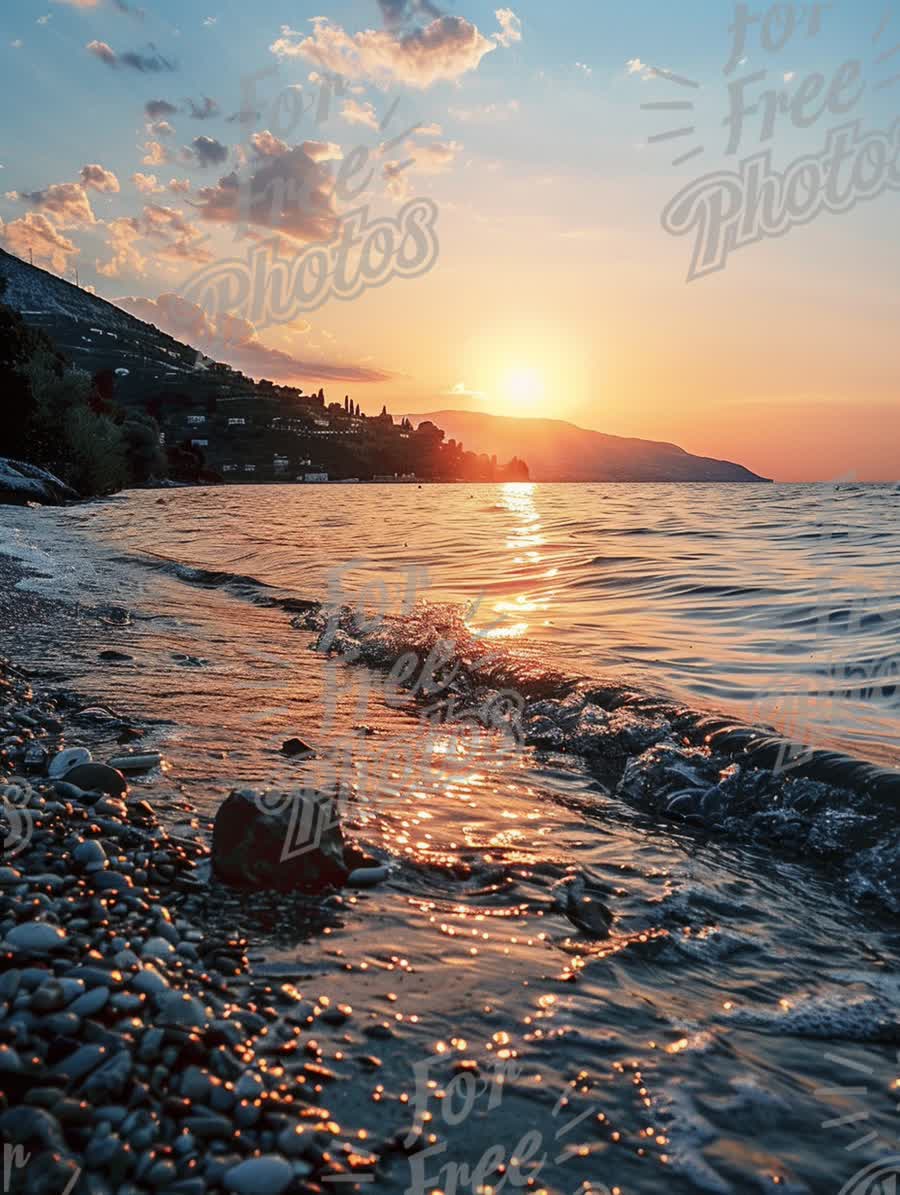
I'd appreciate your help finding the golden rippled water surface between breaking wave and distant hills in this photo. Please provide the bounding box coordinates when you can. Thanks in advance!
[28,484,900,764]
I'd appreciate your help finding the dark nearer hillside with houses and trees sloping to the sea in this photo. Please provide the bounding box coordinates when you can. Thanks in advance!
[0,251,528,494]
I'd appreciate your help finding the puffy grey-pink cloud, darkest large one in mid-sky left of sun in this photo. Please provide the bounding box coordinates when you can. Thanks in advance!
[195,144,337,241]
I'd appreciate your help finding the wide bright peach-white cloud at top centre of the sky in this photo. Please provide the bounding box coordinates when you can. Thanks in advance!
[270,17,496,88]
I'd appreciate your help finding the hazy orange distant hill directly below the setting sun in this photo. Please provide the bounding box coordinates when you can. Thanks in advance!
[409,411,769,482]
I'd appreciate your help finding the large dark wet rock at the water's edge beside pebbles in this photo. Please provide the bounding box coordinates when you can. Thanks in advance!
[213,790,349,891]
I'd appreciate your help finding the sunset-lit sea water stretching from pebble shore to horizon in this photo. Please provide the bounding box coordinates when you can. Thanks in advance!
[0,485,900,1195]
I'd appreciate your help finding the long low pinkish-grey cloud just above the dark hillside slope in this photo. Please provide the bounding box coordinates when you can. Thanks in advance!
[115,293,392,382]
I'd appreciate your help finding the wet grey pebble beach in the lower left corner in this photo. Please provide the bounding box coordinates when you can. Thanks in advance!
[0,661,392,1195]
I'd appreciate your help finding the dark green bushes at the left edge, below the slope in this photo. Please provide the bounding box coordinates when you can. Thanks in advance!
[0,278,166,497]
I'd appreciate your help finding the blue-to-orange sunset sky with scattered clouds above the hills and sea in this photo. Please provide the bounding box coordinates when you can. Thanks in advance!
[0,0,900,480]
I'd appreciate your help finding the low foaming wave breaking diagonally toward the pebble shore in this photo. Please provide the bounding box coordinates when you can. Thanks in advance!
[131,549,900,913]
